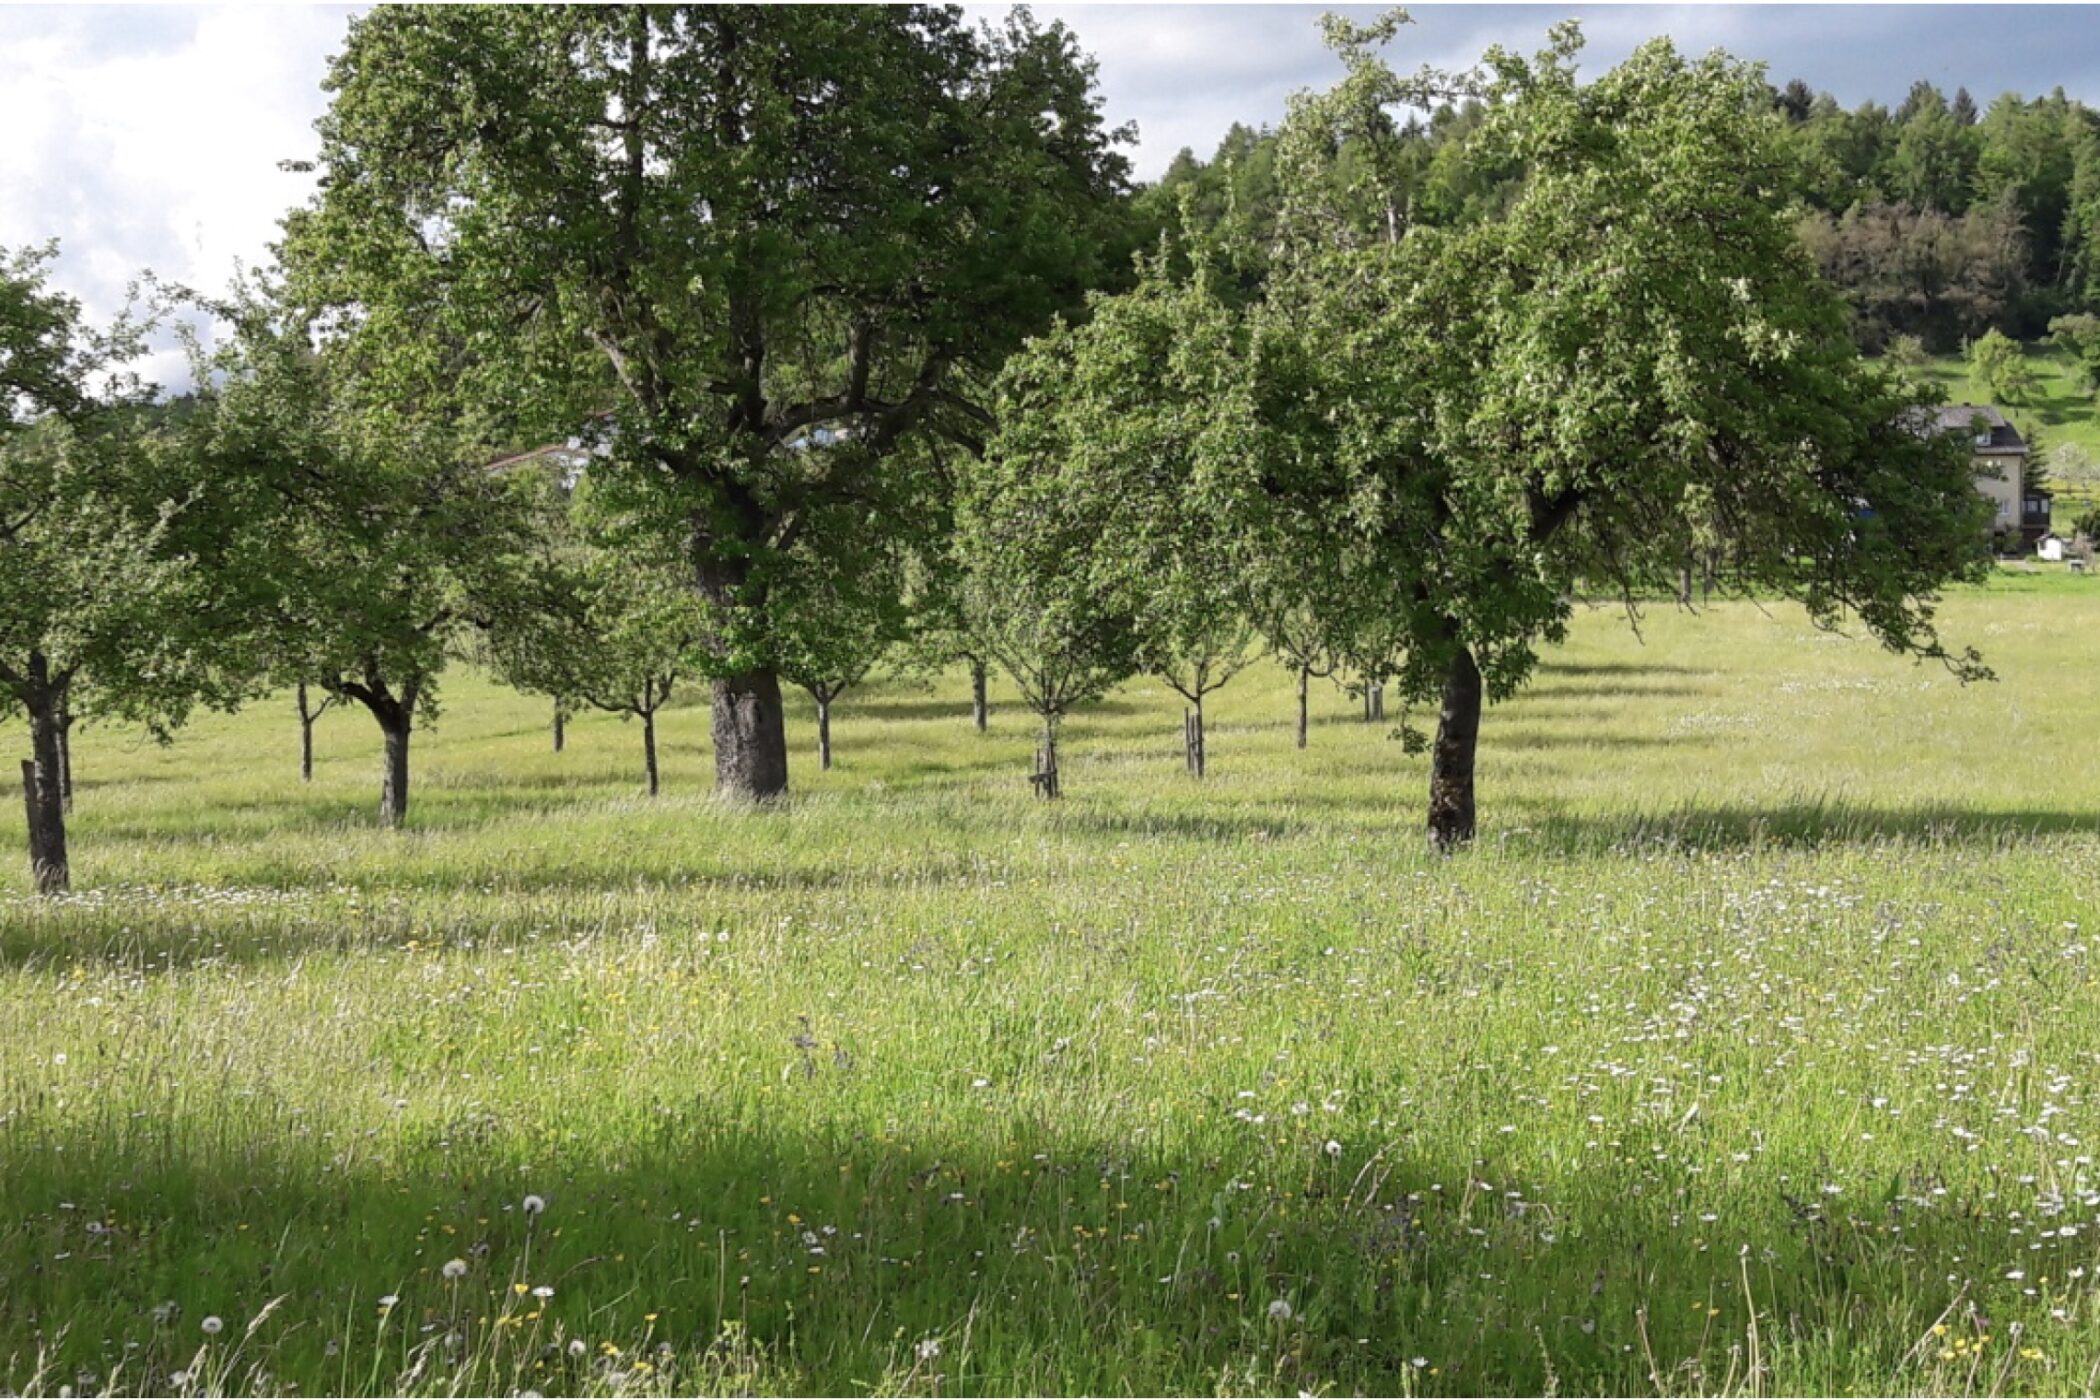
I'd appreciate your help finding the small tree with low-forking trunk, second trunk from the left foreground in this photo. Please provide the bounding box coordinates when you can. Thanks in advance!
[189,298,540,827]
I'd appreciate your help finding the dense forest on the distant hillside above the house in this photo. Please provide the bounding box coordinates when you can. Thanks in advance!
[1142,80,2100,353]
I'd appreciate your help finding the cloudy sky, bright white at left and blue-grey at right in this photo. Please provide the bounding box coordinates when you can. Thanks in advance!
[12,4,2100,384]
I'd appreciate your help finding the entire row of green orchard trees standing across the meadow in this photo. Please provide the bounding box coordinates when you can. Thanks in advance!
[0,6,1982,890]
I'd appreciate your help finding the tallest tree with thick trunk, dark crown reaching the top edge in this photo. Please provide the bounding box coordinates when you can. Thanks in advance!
[288,4,1126,798]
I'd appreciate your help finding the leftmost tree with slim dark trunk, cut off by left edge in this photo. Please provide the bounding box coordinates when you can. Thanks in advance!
[0,246,242,894]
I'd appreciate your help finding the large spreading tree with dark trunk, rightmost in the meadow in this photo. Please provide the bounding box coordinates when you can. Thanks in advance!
[1256,27,1982,848]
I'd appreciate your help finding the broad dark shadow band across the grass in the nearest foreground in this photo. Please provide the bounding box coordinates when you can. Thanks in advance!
[0,1116,2049,1394]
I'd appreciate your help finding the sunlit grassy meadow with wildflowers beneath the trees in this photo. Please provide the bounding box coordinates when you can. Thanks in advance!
[0,573,2100,1394]
